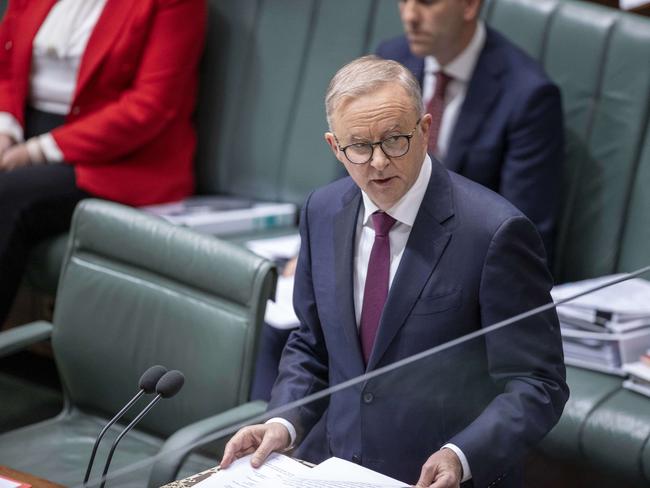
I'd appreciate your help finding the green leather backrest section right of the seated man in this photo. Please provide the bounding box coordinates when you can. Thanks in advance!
[484,0,650,281]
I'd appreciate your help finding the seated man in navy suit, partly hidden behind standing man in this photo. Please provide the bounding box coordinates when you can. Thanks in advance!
[377,0,564,261]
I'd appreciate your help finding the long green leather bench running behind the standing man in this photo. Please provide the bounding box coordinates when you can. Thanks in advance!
[3,0,650,486]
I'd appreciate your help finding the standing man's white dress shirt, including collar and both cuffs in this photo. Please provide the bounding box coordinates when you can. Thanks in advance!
[267,155,472,481]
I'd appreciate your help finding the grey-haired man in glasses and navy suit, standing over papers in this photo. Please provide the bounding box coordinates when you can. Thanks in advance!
[222,56,568,488]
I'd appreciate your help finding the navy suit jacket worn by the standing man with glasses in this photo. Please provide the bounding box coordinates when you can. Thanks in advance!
[270,161,568,487]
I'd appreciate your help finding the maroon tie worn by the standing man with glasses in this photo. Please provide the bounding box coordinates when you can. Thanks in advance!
[359,212,395,364]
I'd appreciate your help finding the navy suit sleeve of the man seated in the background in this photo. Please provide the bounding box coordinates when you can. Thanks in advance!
[499,83,564,261]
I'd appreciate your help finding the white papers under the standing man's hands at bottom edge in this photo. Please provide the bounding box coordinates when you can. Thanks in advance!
[194,454,405,488]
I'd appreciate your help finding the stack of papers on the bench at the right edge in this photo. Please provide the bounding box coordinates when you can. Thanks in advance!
[551,275,650,376]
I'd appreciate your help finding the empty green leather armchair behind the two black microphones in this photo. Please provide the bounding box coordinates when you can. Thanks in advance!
[0,200,275,486]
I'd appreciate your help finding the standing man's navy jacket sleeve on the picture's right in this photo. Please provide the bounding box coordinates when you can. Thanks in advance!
[450,217,569,486]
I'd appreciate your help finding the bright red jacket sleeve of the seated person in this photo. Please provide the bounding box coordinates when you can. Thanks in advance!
[52,0,206,164]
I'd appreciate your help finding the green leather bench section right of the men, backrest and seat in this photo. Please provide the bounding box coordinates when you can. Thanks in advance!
[483,0,650,487]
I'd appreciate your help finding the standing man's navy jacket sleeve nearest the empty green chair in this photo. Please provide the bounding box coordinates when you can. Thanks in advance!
[269,193,329,444]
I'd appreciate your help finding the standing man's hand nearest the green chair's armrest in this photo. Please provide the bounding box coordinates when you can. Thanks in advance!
[221,422,291,469]
